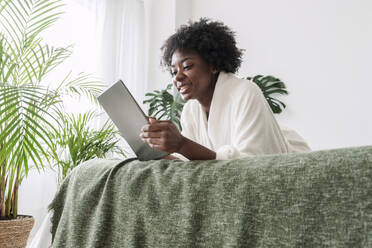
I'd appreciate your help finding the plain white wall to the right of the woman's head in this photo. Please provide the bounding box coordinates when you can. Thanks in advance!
[190,0,372,150]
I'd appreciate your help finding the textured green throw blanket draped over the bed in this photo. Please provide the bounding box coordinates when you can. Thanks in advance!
[50,147,372,248]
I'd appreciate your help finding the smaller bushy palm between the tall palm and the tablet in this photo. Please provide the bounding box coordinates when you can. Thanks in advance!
[50,111,125,182]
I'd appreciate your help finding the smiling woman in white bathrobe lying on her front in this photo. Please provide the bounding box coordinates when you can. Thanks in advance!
[140,19,309,160]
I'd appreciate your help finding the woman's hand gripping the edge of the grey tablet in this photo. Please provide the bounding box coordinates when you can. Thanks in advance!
[140,117,185,153]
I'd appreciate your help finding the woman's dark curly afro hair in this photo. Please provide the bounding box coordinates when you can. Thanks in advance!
[161,18,243,73]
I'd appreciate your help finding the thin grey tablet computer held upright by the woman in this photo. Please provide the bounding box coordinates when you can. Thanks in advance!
[98,80,168,161]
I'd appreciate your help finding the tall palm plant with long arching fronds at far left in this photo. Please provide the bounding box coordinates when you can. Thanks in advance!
[0,0,100,219]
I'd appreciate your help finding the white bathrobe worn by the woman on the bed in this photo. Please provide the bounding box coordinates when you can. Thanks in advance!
[177,72,310,159]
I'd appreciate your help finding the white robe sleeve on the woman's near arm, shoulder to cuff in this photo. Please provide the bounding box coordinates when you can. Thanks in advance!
[216,83,289,160]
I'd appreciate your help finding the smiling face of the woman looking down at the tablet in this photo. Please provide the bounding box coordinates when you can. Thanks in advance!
[171,50,216,104]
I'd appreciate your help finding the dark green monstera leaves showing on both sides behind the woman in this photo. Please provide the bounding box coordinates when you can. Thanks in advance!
[143,75,288,130]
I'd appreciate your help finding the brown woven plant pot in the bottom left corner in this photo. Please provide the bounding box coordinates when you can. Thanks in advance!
[0,215,35,248]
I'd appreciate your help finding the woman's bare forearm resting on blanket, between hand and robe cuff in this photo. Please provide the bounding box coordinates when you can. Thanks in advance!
[178,137,216,160]
